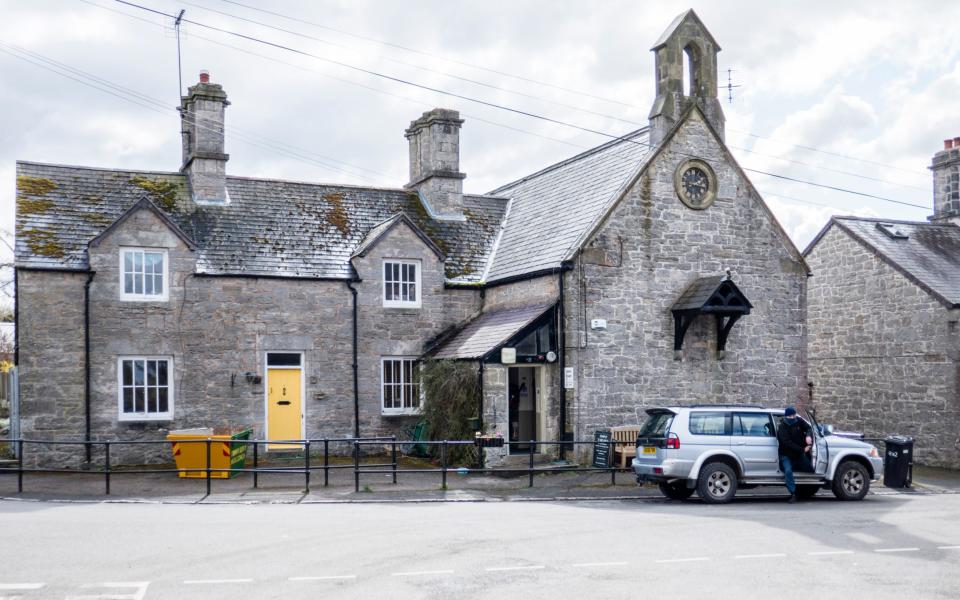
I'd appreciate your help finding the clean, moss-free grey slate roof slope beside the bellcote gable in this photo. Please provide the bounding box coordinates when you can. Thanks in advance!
[486,128,650,282]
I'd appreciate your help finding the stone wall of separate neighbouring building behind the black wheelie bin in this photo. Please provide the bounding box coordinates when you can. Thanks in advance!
[807,225,960,469]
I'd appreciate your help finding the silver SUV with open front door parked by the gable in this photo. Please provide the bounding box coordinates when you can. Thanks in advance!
[633,405,883,503]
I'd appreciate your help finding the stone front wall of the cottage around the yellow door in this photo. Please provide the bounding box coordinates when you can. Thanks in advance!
[20,210,488,467]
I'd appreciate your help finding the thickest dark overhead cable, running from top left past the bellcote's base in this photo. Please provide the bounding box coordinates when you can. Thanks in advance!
[114,0,926,213]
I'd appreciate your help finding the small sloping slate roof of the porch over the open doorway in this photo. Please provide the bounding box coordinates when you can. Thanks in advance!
[430,304,553,359]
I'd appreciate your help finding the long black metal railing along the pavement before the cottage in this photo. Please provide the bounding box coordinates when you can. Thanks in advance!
[0,436,631,495]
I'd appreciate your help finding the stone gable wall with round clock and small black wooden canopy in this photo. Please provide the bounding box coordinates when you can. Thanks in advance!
[565,113,807,462]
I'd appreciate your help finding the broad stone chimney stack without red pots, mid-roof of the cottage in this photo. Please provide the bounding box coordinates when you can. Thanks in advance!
[404,108,466,220]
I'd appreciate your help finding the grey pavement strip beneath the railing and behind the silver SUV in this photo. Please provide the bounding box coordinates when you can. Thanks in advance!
[0,464,960,504]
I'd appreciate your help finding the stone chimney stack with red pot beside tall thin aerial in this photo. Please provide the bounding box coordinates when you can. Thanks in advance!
[180,71,230,204]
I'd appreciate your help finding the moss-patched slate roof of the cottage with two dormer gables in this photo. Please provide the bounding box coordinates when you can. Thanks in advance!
[16,162,507,283]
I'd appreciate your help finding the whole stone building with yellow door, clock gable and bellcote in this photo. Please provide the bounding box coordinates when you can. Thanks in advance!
[16,11,809,468]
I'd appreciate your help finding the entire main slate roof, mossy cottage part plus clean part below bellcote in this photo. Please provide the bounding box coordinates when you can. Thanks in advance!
[16,129,651,284]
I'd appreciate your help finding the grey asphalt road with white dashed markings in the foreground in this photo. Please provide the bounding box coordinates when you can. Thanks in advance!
[0,494,960,600]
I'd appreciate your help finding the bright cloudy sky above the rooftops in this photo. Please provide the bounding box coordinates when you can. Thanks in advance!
[0,0,960,310]
